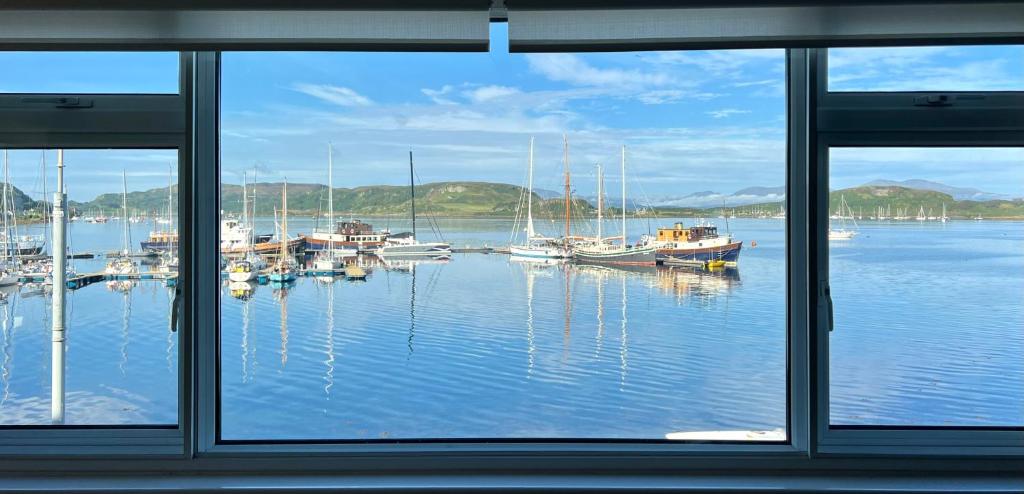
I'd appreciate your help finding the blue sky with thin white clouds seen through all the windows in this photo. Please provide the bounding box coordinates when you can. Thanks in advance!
[0,24,1024,202]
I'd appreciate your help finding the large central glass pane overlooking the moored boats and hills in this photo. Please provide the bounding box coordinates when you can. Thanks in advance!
[220,33,786,441]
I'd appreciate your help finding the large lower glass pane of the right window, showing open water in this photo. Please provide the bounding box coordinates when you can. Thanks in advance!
[828,148,1024,426]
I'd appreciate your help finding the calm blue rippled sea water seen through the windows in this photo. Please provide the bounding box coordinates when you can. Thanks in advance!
[0,219,1024,440]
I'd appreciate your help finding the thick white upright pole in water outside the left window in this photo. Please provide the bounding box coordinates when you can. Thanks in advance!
[50,150,68,424]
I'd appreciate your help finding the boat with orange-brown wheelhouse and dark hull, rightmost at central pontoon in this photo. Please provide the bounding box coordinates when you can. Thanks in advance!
[640,221,743,265]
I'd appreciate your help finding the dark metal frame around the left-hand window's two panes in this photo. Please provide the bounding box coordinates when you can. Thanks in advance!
[0,53,193,457]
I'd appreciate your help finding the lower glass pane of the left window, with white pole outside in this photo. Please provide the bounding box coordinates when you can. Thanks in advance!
[0,150,178,425]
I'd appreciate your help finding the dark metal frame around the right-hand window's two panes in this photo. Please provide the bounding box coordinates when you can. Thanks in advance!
[808,49,1024,459]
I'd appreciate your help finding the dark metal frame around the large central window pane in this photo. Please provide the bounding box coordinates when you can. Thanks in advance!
[196,49,809,458]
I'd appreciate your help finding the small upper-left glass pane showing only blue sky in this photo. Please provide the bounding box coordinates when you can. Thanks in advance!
[0,51,179,94]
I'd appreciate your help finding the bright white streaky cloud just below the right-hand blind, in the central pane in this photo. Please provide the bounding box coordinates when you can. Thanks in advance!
[526,53,672,87]
